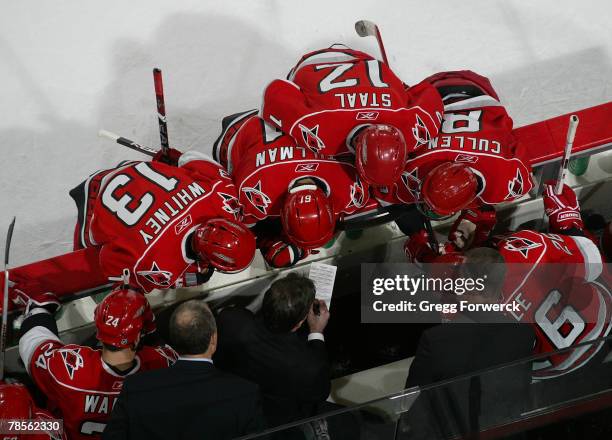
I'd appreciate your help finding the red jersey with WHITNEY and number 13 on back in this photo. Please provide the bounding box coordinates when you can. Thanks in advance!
[71,152,240,292]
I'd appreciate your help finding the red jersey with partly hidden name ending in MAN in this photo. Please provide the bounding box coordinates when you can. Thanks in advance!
[228,116,369,225]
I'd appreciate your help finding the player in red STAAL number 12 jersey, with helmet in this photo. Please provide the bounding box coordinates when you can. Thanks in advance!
[260,45,442,186]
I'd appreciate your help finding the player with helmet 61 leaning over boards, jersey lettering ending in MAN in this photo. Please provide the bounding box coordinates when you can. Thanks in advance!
[216,113,369,267]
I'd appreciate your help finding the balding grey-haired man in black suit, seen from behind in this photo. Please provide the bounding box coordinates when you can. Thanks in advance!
[103,300,264,440]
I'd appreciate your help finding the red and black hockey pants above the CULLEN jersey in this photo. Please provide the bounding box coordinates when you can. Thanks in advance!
[425,70,499,104]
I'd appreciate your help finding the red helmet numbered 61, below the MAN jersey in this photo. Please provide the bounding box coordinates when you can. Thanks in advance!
[281,184,336,249]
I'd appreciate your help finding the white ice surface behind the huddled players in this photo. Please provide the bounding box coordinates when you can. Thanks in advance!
[0,0,612,264]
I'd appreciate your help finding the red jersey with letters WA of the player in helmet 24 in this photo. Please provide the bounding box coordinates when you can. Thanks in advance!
[19,326,178,440]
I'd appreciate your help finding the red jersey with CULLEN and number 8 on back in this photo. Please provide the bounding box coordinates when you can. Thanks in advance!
[375,96,533,205]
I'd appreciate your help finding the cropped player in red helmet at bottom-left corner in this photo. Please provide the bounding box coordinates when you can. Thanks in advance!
[0,382,68,440]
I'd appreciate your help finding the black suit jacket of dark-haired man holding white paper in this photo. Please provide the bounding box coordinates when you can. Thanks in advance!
[215,307,331,426]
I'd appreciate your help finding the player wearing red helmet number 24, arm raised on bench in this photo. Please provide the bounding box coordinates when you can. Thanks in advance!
[17,287,177,440]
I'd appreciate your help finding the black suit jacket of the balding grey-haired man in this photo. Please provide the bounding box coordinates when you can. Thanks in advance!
[102,360,264,440]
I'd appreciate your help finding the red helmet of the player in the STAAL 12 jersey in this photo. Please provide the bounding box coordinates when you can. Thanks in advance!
[354,124,407,186]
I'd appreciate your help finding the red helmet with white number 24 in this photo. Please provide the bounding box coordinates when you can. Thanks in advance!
[94,288,155,348]
